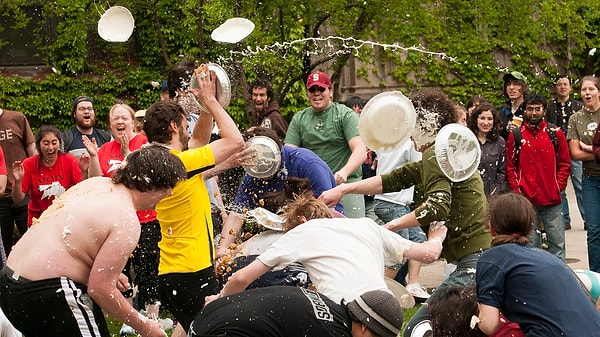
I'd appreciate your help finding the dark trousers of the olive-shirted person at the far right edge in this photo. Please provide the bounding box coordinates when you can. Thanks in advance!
[582,174,600,273]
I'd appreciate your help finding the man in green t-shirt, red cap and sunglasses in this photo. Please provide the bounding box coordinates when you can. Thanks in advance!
[285,71,367,218]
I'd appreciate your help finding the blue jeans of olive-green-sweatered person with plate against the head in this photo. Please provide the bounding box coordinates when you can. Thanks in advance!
[403,253,481,337]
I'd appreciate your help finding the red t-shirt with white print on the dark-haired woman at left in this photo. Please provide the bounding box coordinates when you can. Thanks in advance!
[21,152,81,226]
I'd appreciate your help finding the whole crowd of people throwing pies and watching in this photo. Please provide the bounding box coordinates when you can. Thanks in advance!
[0,59,600,337]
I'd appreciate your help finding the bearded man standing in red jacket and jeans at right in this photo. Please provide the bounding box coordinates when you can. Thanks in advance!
[506,93,571,261]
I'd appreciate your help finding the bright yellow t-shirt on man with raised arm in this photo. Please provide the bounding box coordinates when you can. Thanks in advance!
[156,146,215,275]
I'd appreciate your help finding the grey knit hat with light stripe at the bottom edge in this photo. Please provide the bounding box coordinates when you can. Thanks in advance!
[346,290,404,337]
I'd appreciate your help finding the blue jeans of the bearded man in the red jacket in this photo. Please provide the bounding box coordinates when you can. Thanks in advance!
[528,204,565,261]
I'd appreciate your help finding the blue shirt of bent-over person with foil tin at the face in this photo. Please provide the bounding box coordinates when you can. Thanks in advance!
[232,146,344,213]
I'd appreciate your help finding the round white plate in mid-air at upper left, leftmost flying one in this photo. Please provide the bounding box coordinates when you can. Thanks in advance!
[98,6,135,42]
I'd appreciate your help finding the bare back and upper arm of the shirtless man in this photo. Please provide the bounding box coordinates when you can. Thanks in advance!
[7,178,140,285]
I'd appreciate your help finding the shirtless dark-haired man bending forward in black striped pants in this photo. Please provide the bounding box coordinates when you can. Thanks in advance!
[0,145,186,337]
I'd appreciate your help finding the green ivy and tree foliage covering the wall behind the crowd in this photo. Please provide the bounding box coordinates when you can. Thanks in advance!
[0,0,600,131]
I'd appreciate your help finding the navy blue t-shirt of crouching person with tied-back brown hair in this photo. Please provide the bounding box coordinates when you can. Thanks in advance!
[476,243,600,337]
